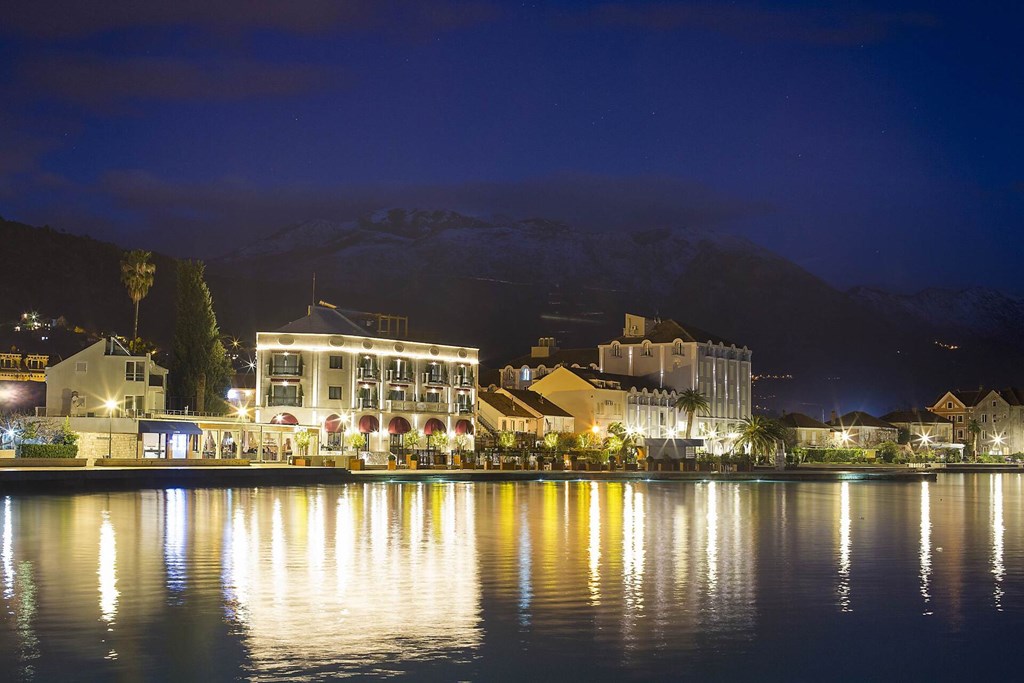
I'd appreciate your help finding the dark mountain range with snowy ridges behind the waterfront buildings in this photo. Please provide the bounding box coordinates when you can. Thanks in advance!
[0,209,1024,415]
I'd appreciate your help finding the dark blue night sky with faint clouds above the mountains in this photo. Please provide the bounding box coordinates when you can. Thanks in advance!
[0,0,1024,293]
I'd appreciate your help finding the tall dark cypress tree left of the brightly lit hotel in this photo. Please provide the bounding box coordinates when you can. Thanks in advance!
[170,261,231,413]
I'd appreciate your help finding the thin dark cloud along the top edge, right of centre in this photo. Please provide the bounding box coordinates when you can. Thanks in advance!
[564,2,936,46]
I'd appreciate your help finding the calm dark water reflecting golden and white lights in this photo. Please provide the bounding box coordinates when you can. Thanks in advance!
[0,474,1024,681]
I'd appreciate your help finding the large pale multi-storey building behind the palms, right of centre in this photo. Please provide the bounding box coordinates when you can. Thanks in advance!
[598,313,751,434]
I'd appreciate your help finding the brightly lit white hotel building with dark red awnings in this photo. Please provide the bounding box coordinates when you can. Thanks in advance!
[255,306,479,454]
